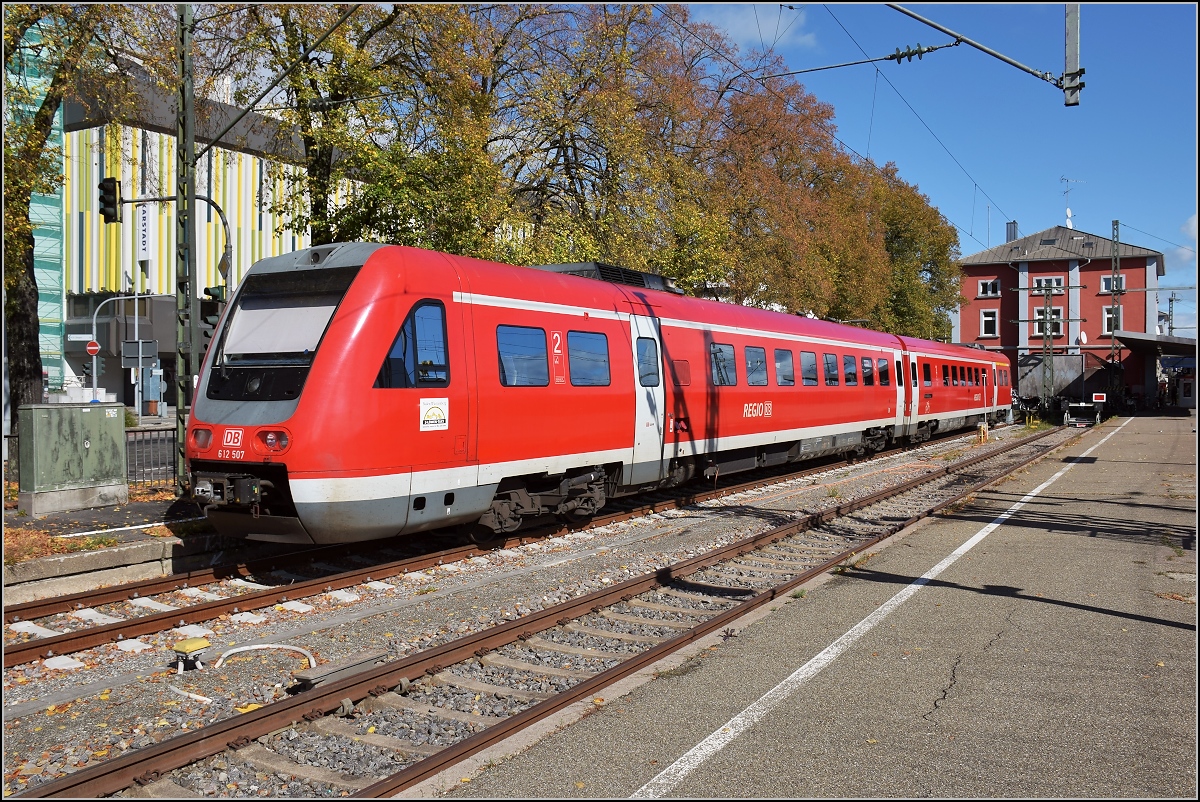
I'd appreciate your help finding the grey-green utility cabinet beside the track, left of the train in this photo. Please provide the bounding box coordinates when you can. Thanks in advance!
[17,403,130,515]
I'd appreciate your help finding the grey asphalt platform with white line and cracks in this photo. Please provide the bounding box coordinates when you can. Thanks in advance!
[429,411,1198,798]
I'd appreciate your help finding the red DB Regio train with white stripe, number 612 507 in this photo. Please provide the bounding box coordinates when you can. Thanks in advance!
[186,243,1012,544]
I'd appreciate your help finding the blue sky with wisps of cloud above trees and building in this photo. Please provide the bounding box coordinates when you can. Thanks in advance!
[689,4,1196,337]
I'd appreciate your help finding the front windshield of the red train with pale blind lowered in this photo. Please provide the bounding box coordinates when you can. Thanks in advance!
[214,268,359,367]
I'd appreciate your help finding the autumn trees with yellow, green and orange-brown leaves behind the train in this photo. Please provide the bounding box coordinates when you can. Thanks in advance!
[5,4,959,420]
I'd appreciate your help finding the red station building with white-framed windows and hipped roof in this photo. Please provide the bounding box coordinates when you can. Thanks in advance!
[953,223,1166,400]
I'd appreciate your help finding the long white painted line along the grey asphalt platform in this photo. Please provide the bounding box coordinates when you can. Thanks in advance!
[630,418,1133,800]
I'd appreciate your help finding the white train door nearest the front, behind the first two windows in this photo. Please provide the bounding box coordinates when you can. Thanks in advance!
[625,315,666,485]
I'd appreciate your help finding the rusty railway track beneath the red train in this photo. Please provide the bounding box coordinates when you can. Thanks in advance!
[4,425,998,669]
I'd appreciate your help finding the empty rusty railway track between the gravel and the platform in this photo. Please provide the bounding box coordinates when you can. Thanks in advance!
[9,422,1079,797]
